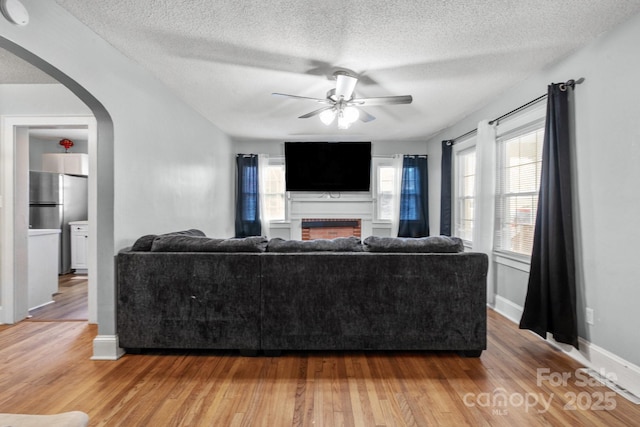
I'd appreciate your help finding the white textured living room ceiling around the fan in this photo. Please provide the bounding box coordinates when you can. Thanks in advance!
[3,0,640,140]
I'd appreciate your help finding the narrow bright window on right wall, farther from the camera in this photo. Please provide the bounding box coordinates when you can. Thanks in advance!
[454,147,476,243]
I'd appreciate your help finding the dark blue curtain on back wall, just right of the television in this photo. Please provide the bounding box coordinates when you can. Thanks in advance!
[398,156,429,237]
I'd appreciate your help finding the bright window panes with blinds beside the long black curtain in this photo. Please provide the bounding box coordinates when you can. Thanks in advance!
[495,123,544,255]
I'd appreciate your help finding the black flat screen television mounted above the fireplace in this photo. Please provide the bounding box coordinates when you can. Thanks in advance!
[284,142,371,192]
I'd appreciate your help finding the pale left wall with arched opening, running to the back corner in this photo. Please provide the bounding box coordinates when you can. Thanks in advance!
[0,0,233,354]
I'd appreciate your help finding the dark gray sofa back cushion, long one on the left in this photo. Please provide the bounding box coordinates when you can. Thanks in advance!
[151,234,267,252]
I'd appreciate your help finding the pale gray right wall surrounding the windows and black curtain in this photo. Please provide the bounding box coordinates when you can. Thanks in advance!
[428,15,640,366]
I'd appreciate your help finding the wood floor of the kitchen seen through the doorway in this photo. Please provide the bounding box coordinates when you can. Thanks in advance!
[29,274,88,321]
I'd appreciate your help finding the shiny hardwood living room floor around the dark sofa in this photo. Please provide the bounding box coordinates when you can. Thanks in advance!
[0,310,640,427]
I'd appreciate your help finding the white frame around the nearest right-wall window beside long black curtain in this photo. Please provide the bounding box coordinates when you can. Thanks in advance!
[493,102,546,264]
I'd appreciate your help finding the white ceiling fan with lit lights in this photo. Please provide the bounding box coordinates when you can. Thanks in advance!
[272,71,413,129]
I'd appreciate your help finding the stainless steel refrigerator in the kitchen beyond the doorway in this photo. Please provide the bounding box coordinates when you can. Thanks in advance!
[29,171,89,274]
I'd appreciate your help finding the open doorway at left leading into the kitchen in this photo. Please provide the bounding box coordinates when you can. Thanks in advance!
[28,126,90,321]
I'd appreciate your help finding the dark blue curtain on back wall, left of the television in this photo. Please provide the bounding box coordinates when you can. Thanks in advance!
[236,154,262,241]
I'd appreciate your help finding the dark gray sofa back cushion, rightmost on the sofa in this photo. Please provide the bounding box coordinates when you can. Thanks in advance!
[363,236,464,253]
